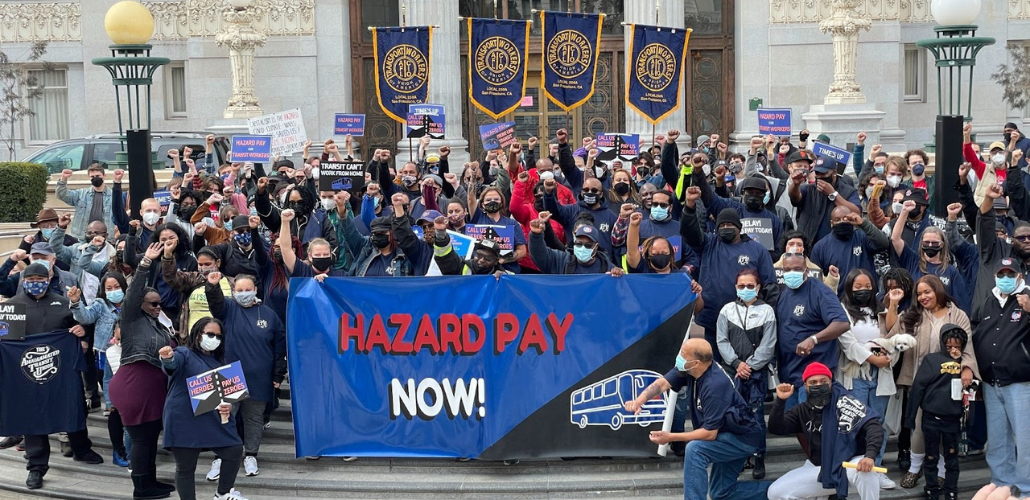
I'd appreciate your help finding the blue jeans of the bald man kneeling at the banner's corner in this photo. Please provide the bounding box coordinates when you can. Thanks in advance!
[683,432,773,500]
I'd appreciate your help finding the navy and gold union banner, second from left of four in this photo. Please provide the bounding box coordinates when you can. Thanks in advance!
[467,19,530,120]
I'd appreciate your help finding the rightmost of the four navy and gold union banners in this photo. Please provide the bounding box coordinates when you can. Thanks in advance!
[626,25,691,125]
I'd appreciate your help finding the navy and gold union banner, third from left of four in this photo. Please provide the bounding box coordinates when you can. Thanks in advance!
[540,11,605,111]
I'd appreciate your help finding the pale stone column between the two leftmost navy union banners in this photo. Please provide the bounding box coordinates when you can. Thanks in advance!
[397,0,469,164]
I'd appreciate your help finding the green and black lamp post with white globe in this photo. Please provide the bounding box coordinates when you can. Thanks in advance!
[916,0,995,216]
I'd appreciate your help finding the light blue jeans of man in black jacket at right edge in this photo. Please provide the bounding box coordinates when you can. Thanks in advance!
[984,382,1030,495]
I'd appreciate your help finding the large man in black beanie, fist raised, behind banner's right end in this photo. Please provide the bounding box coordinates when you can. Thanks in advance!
[680,186,780,363]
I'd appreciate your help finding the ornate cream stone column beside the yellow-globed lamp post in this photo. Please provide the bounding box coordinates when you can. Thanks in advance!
[214,0,265,120]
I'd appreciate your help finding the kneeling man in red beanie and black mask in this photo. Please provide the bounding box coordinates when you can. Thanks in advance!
[768,362,886,500]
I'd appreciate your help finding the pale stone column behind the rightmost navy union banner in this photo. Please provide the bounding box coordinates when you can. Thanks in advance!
[619,0,691,149]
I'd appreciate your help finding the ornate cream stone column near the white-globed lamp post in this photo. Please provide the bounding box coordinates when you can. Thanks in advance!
[819,0,872,104]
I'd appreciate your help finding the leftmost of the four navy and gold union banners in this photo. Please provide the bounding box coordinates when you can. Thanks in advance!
[372,26,433,124]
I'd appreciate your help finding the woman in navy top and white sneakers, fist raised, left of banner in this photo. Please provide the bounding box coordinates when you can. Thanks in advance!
[205,272,286,480]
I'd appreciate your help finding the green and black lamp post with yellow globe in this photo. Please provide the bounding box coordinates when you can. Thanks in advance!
[93,0,171,218]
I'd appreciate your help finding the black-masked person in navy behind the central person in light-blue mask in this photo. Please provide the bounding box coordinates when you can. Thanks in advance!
[544,175,619,260]
